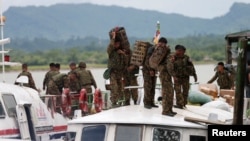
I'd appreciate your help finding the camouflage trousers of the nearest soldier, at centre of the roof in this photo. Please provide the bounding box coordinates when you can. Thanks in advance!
[160,72,174,114]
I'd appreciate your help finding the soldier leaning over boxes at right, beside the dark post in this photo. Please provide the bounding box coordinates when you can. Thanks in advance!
[207,62,233,89]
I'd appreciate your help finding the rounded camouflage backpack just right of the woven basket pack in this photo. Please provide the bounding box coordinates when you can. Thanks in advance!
[149,47,168,70]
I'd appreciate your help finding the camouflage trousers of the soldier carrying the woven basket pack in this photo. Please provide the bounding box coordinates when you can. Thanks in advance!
[143,71,157,105]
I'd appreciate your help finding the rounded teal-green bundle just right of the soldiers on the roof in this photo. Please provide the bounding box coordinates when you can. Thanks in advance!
[188,91,212,105]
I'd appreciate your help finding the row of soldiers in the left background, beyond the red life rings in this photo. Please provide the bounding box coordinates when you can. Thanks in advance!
[15,62,97,112]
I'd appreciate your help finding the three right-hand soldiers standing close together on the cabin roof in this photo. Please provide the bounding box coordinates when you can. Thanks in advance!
[142,37,197,116]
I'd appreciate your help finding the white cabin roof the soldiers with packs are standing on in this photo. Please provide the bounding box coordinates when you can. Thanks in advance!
[68,105,233,128]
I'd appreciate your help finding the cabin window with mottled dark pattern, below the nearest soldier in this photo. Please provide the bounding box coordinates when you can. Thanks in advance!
[153,128,181,141]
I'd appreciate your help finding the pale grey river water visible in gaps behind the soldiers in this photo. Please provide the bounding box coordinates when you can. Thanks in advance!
[0,64,216,93]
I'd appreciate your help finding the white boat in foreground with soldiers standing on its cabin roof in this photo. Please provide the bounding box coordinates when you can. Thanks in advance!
[63,105,233,141]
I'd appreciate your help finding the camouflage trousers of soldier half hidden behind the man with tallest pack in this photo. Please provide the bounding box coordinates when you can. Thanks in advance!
[124,77,138,105]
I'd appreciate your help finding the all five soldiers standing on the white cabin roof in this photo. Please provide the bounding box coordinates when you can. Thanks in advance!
[107,29,197,116]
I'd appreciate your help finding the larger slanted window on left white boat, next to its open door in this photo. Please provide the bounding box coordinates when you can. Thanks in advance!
[3,94,17,116]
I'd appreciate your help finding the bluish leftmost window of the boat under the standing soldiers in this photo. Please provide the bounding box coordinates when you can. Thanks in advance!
[81,125,106,141]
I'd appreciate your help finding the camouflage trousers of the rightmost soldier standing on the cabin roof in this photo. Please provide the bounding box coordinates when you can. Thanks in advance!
[174,77,190,106]
